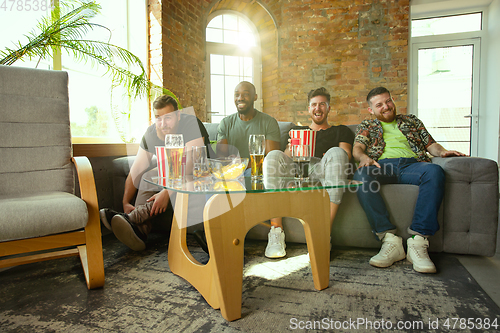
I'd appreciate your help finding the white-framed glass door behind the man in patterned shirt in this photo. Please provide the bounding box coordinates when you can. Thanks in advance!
[412,38,480,156]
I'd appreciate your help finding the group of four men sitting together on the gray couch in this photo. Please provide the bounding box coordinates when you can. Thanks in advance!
[100,81,465,273]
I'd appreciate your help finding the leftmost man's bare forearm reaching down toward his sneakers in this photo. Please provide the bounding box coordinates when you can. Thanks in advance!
[122,147,152,214]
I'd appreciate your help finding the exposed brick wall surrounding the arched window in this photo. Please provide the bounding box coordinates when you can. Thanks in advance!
[150,0,409,124]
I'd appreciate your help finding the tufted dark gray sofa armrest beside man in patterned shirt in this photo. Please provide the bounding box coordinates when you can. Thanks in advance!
[432,157,498,256]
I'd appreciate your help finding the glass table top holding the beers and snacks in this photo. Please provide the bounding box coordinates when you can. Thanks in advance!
[144,176,362,194]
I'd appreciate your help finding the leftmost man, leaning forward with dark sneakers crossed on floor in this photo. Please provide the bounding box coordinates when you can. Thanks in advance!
[100,95,210,251]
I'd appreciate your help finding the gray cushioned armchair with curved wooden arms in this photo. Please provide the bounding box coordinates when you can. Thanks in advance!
[0,66,104,289]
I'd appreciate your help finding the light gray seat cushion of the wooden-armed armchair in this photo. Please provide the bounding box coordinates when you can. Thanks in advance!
[0,192,88,241]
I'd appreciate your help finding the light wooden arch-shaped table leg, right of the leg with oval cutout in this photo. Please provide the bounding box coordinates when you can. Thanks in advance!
[204,191,330,321]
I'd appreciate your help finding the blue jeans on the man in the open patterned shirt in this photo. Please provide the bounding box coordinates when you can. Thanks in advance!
[354,158,445,236]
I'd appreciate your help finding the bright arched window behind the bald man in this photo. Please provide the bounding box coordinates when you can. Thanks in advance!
[206,12,262,123]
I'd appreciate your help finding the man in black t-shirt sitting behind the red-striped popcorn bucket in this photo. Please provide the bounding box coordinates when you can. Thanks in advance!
[264,87,354,258]
